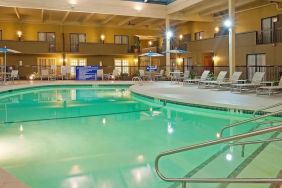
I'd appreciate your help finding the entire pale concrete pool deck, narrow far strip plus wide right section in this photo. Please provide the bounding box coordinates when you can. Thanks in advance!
[0,80,282,111]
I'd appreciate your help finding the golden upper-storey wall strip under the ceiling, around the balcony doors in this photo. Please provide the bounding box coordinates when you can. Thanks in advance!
[0,22,160,51]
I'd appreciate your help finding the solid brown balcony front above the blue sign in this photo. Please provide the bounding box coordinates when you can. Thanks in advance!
[78,43,129,55]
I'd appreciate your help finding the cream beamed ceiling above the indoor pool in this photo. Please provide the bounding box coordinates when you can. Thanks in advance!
[0,0,281,30]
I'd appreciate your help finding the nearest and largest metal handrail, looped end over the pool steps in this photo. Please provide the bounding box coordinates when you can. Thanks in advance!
[155,124,282,184]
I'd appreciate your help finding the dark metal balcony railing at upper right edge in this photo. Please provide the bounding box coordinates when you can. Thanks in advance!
[257,29,282,44]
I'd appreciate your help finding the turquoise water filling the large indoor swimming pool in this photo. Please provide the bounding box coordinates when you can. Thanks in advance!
[0,86,280,188]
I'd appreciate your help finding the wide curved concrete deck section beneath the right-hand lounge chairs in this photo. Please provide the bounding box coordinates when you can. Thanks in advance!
[130,82,282,111]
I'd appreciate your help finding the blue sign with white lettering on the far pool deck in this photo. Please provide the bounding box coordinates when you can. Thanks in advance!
[75,66,99,80]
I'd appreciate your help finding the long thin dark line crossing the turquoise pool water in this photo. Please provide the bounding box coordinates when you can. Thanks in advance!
[0,107,162,125]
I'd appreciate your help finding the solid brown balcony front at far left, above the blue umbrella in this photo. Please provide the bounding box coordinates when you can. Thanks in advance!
[0,40,49,54]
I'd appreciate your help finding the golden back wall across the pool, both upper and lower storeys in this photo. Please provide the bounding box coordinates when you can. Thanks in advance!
[0,22,165,78]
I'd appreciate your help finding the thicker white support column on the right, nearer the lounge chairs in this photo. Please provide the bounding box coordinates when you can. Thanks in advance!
[228,0,236,77]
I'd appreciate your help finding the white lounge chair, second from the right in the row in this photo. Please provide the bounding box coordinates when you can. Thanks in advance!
[231,72,265,93]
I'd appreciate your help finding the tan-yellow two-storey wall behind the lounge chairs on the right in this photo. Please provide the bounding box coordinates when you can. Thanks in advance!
[177,5,282,69]
